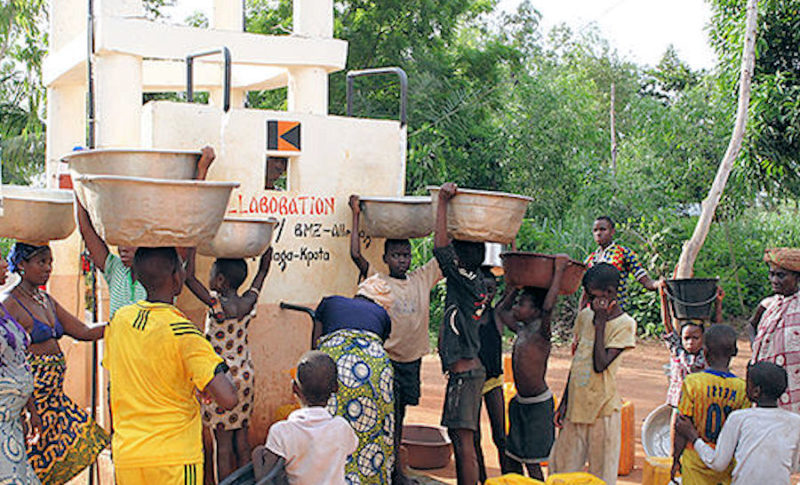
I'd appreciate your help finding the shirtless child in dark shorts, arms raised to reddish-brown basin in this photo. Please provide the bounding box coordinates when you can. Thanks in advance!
[497,254,569,480]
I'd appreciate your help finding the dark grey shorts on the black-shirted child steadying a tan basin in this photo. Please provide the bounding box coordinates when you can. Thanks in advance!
[442,367,486,431]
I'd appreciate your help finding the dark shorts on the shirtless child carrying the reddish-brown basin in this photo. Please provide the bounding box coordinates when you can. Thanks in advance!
[506,390,556,463]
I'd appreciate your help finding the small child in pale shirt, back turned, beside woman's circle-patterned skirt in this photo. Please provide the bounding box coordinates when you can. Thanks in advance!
[254,350,358,485]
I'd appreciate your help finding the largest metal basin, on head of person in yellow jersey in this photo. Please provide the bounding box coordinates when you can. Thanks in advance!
[74,175,239,247]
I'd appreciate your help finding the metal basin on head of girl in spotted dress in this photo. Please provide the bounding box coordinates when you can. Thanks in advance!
[197,217,278,258]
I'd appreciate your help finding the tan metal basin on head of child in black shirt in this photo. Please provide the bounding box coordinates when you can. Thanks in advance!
[428,187,533,244]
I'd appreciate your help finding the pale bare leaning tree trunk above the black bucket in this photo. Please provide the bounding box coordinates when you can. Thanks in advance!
[676,0,758,278]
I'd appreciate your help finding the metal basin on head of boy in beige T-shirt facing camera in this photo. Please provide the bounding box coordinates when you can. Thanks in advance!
[361,196,433,239]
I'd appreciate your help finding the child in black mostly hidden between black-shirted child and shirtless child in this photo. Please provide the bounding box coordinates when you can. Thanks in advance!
[475,266,506,482]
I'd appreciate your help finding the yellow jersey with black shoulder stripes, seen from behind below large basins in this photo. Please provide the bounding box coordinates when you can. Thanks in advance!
[103,301,222,468]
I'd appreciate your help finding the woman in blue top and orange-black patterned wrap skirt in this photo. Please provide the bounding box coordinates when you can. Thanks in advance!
[0,242,109,484]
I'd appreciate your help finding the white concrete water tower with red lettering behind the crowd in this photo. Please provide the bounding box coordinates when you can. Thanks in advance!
[44,0,406,442]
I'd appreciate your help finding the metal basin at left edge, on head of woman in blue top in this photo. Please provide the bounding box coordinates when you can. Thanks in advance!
[0,185,75,244]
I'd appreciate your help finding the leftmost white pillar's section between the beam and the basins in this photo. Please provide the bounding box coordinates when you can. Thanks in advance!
[45,84,86,187]
